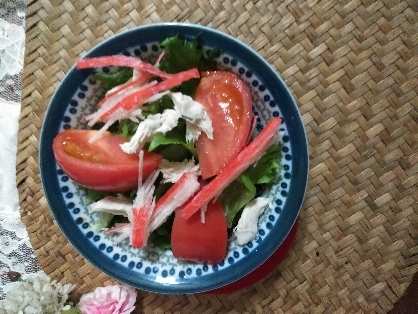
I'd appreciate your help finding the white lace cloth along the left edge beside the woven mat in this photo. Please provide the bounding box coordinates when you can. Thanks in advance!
[0,0,41,299]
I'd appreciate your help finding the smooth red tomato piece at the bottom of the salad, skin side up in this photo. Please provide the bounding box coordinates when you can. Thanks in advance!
[171,201,228,264]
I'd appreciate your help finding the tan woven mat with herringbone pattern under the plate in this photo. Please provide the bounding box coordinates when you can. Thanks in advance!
[17,0,418,313]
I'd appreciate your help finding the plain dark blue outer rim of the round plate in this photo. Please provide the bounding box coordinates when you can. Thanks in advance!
[39,22,309,294]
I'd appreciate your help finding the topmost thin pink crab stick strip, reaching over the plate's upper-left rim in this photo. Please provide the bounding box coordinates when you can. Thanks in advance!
[76,55,173,78]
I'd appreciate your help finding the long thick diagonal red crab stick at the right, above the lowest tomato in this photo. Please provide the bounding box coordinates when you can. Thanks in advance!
[181,118,282,219]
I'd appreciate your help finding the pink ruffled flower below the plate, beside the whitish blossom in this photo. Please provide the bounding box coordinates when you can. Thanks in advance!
[78,285,136,314]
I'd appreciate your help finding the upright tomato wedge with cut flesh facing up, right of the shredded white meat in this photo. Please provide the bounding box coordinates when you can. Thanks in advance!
[194,71,253,179]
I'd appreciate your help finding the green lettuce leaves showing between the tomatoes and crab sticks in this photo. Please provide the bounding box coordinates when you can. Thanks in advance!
[86,35,283,249]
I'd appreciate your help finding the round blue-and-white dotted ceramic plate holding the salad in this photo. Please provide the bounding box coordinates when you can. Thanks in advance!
[40,23,308,294]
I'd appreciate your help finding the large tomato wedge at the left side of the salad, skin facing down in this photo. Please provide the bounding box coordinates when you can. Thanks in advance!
[52,129,162,192]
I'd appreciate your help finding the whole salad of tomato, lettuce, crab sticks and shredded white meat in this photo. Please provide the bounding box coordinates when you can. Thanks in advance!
[53,36,282,264]
